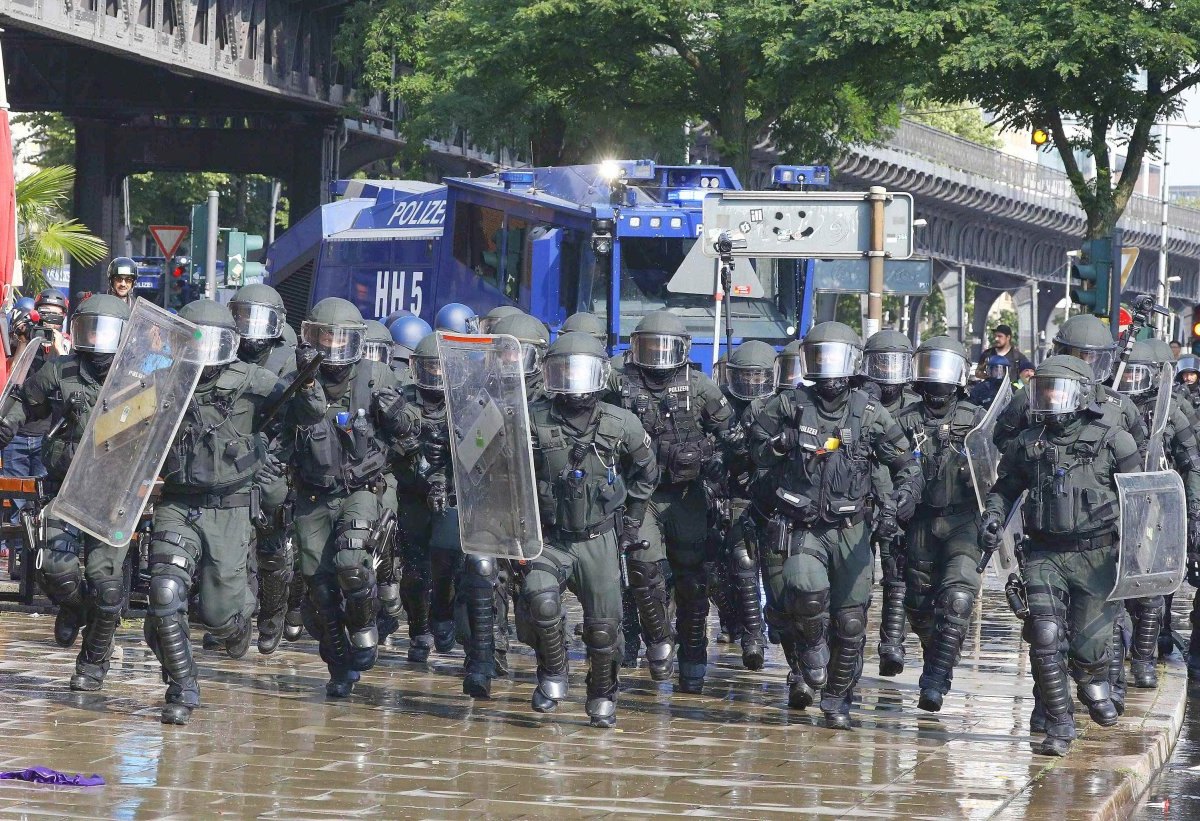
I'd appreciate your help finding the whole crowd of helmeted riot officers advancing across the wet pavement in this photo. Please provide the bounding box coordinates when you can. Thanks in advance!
[0,261,1200,755]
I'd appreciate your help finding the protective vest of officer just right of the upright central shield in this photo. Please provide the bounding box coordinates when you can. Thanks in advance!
[529,402,625,532]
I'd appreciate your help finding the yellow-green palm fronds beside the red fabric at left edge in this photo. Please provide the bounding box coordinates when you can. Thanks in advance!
[16,166,108,293]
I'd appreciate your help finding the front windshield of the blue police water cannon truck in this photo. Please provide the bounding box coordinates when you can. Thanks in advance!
[590,236,799,344]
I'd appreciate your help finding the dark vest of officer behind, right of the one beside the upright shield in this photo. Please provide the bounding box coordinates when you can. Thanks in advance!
[620,365,715,485]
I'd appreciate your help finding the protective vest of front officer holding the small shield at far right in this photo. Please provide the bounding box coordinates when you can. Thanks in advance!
[1020,414,1121,537]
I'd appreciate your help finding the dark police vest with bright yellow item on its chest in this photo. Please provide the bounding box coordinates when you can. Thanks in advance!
[780,389,877,522]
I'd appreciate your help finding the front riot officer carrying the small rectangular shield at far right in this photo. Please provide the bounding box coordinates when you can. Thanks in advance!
[983,355,1141,755]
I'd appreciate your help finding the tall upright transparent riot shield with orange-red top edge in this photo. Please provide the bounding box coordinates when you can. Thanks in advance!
[438,332,542,559]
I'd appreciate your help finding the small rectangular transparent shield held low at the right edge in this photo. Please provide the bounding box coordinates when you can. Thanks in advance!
[1109,471,1188,601]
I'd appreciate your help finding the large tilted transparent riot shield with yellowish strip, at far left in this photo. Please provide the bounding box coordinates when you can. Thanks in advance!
[49,299,200,546]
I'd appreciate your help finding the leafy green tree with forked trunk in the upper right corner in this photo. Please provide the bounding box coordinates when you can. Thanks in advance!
[804,0,1200,239]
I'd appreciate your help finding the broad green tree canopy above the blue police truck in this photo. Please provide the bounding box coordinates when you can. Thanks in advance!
[341,0,902,176]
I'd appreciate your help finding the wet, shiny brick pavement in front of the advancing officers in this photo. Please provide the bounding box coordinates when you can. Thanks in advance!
[0,573,1182,821]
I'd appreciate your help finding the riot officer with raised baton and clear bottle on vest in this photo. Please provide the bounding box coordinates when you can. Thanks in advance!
[290,296,420,697]
